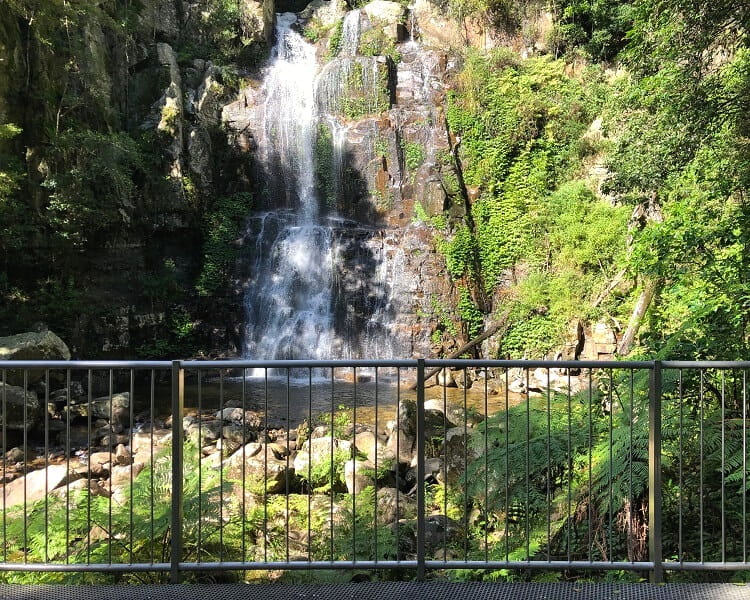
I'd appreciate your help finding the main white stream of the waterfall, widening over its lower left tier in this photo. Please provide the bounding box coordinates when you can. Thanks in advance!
[246,13,333,359]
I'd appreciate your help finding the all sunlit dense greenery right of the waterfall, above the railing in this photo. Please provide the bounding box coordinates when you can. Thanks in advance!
[426,0,750,359]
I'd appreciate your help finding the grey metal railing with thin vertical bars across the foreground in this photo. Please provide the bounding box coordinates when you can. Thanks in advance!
[0,359,750,582]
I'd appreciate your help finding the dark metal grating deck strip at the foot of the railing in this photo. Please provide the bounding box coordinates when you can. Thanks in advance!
[0,582,750,600]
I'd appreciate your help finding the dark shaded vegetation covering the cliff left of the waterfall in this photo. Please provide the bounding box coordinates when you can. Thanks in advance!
[0,0,258,356]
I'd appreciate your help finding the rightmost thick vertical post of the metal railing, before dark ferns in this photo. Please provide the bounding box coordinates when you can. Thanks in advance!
[648,360,664,583]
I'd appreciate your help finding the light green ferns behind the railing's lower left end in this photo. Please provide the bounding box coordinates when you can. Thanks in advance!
[3,444,229,583]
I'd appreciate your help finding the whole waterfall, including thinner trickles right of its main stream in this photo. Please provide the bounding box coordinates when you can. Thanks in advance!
[245,11,403,375]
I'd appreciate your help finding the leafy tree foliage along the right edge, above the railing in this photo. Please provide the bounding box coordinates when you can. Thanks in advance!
[606,0,750,359]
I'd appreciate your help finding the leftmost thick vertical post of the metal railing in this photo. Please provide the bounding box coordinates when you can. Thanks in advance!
[169,360,185,583]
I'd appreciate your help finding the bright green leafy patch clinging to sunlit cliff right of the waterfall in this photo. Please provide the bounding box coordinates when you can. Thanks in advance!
[445,51,601,292]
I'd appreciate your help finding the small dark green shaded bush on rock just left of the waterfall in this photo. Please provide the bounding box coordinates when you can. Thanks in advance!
[196,192,252,296]
